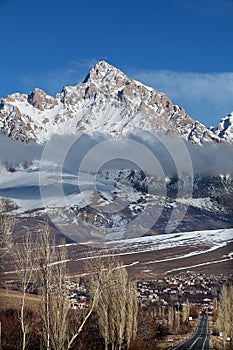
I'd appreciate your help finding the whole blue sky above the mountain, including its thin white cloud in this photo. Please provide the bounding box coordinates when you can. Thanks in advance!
[0,0,233,125]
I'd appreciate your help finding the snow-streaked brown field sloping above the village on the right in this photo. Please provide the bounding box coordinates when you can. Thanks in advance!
[57,229,233,274]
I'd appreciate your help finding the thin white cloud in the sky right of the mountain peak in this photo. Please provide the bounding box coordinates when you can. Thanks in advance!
[133,70,233,124]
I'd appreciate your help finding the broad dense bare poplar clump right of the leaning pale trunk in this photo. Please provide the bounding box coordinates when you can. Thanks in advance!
[90,256,138,350]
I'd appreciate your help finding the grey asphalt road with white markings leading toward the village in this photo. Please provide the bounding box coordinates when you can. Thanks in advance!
[171,315,210,350]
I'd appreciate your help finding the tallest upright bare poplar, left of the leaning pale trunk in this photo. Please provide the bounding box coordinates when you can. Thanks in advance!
[37,225,70,350]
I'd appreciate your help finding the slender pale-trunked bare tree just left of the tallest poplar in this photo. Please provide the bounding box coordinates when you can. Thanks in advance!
[15,232,36,350]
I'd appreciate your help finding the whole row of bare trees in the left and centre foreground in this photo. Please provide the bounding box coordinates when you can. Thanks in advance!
[12,225,138,350]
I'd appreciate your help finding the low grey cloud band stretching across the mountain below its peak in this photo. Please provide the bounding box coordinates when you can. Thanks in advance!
[0,131,233,176]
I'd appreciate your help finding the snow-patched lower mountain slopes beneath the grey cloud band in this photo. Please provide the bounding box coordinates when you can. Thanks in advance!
[0,163,233,242]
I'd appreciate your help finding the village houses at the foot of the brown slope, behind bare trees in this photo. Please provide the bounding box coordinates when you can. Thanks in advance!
[64,271,233,310]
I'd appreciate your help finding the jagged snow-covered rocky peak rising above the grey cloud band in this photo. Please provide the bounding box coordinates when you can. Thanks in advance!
[0,61,224,144]
